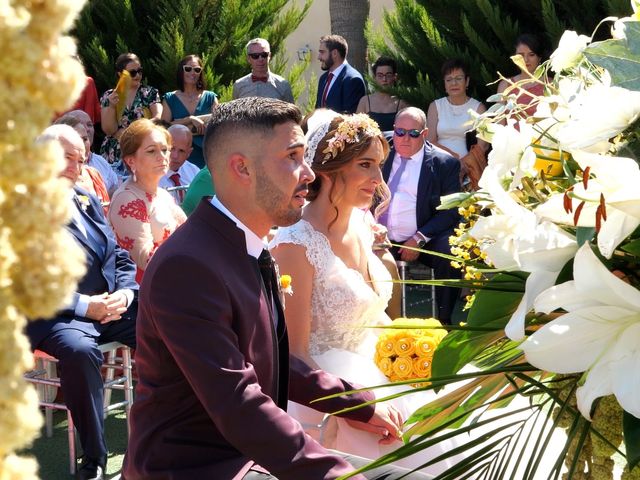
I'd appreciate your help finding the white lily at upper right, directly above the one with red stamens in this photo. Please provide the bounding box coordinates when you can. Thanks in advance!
[556,84,640,153]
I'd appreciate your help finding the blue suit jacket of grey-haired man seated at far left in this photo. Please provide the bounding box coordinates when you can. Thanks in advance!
[26,187,138,348]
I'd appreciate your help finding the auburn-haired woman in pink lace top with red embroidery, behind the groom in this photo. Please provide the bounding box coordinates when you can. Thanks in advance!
[109,119,186,282]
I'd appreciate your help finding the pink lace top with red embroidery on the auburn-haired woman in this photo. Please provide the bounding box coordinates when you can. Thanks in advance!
[109,180,187,282]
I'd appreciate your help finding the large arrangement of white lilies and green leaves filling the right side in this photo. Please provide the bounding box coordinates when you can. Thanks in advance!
[350,0,640,480]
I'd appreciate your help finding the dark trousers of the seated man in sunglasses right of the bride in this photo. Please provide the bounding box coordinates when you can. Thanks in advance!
[390,232,460,324]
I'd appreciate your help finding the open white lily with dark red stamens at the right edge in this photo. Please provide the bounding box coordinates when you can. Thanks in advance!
[535,151,640,258]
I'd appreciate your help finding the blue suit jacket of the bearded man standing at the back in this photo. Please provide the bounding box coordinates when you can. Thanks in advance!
[316,62,366,113]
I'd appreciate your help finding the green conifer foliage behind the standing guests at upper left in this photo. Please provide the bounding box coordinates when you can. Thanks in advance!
[73,0,311,99]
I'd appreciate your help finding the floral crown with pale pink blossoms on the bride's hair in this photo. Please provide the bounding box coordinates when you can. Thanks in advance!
[305,113,382,164]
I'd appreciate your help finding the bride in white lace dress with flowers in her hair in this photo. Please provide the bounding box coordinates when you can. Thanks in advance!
[271,111,455,474]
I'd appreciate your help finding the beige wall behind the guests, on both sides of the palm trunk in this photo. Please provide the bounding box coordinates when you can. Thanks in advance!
[285,0,394,103]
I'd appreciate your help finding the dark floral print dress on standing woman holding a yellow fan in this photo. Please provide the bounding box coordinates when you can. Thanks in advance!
[100,85,160,178]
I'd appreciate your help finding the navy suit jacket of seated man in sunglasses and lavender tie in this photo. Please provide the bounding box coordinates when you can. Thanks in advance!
[382,142,461,238]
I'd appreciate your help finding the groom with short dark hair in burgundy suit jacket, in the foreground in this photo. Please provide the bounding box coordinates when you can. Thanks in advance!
[123,97,425,480]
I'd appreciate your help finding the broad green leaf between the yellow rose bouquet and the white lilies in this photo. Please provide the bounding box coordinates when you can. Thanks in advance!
[432,272,528,377]
